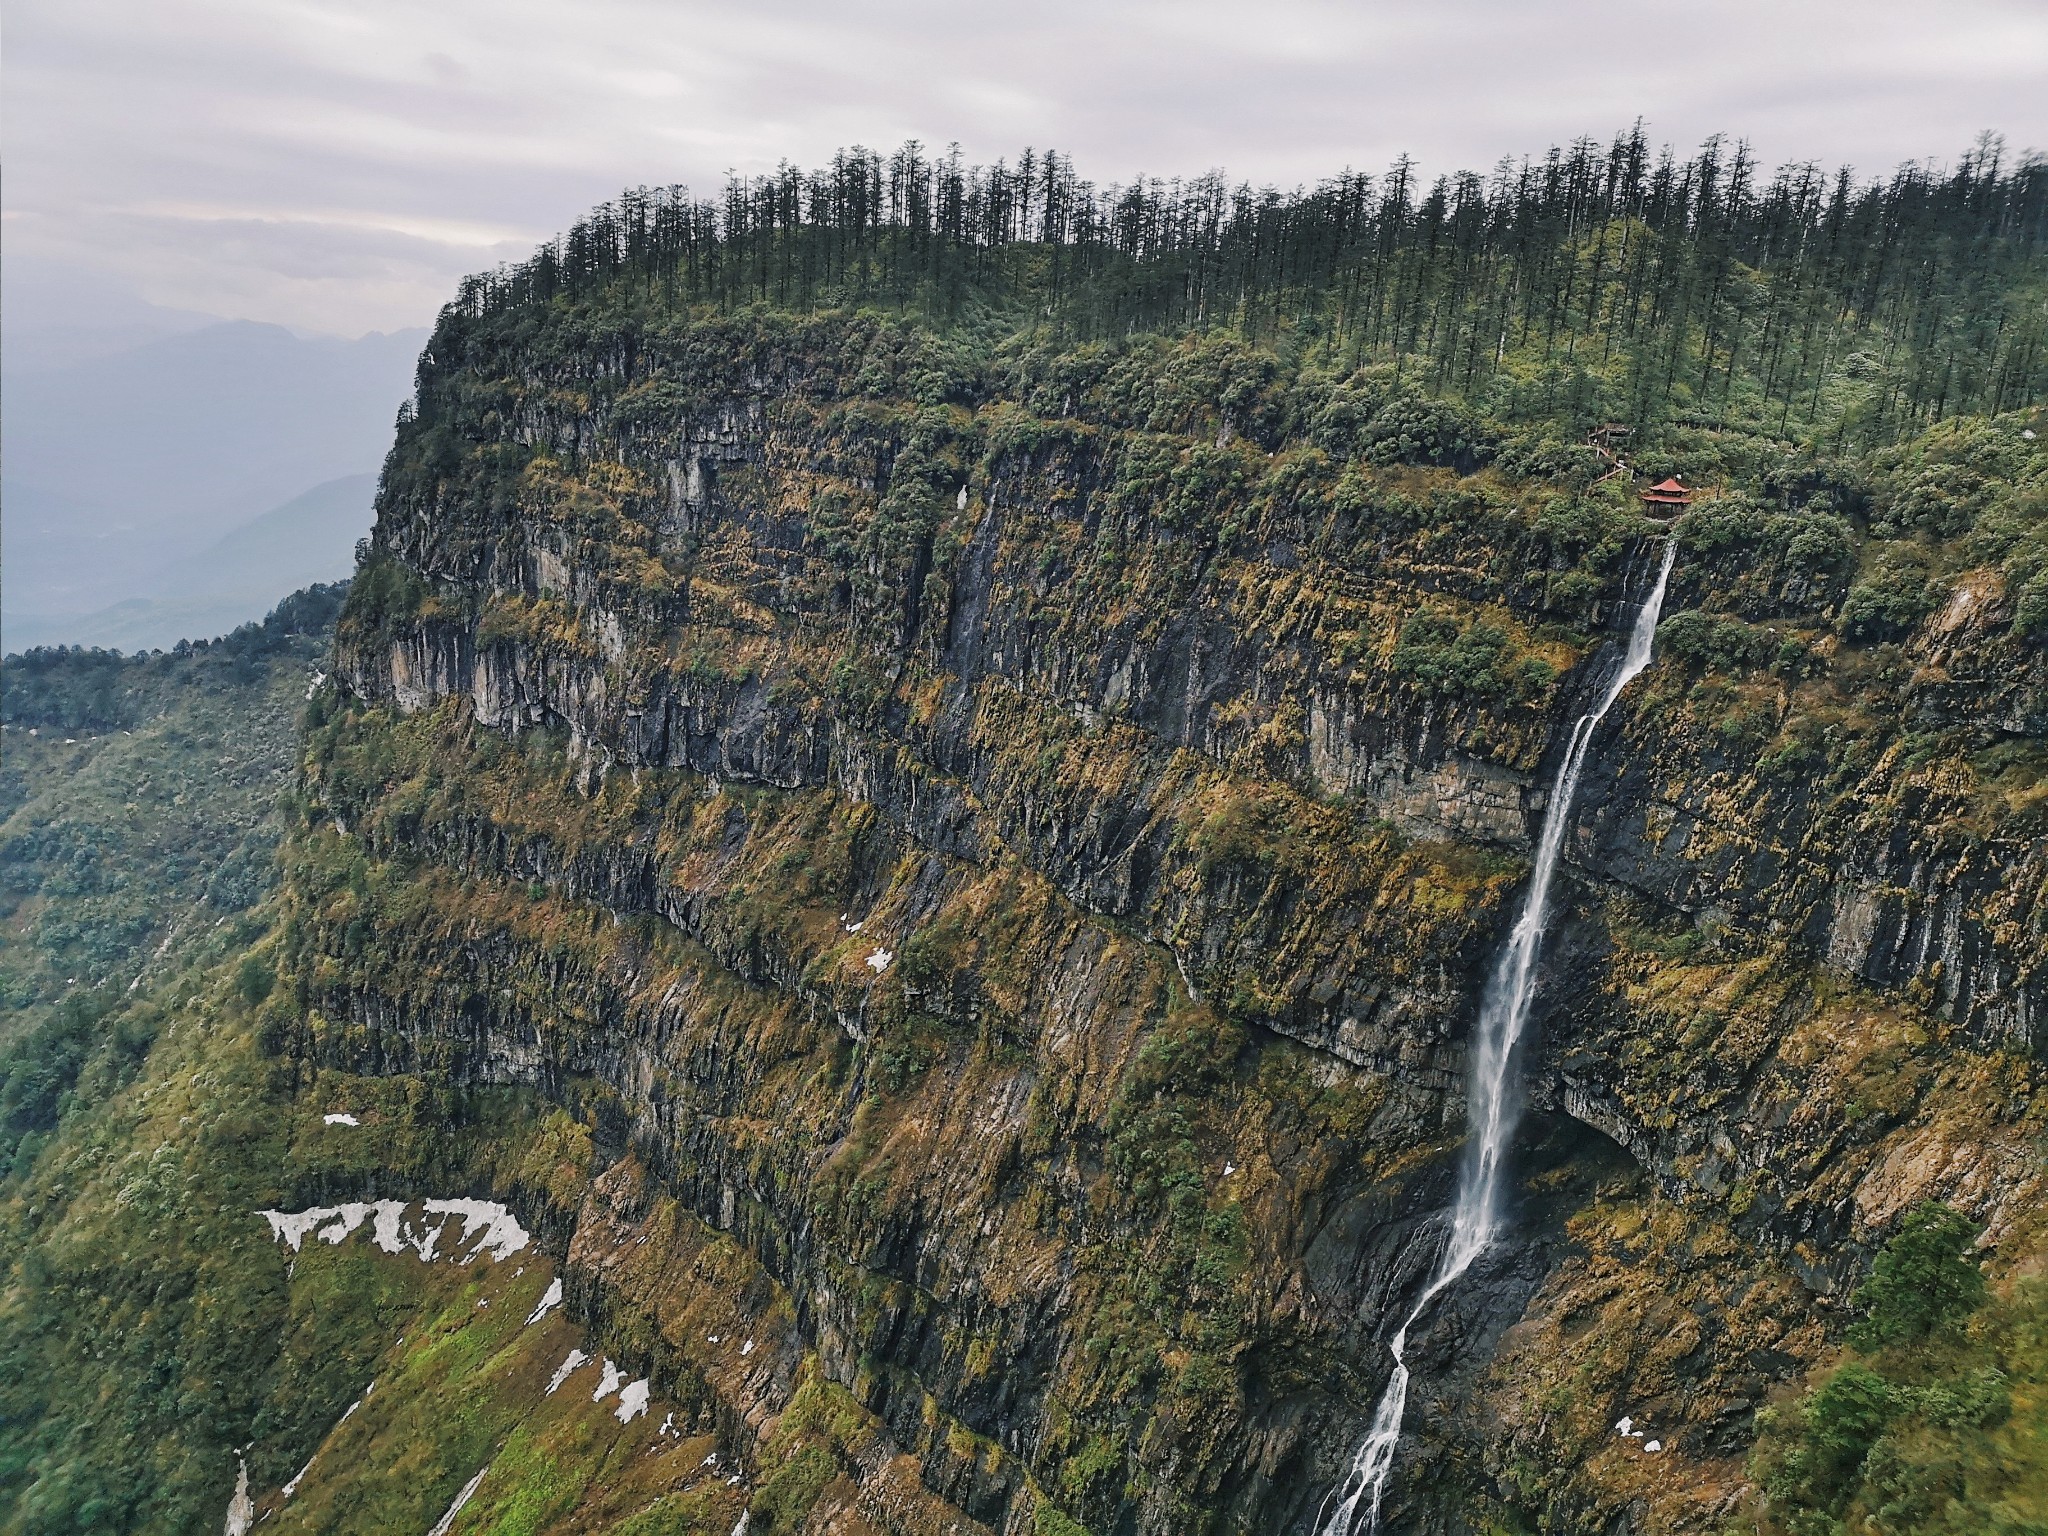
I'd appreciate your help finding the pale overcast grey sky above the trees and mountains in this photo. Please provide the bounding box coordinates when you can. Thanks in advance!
[0,0,2048,336]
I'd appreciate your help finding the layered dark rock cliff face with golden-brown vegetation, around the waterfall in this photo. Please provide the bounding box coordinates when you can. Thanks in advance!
[292,317,2048,1534]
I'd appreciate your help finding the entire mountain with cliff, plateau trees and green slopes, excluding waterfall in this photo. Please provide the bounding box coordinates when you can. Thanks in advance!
[0,133,2048,1536]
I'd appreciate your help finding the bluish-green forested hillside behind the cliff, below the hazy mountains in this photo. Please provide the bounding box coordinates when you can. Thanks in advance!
[0,588,342,1165]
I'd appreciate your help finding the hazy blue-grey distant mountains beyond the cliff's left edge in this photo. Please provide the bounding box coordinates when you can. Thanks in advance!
[0,322,426,651]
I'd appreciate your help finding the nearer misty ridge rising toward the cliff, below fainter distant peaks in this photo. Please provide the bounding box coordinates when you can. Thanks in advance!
[48,475,377,651]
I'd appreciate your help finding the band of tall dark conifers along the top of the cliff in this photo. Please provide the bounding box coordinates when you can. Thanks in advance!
[449,125,2048,442]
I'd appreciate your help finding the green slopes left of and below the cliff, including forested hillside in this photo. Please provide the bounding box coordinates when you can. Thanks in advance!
[0,606,770,1534]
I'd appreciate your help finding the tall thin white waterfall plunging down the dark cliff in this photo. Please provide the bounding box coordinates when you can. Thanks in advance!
[1317,539,1677,1536]
